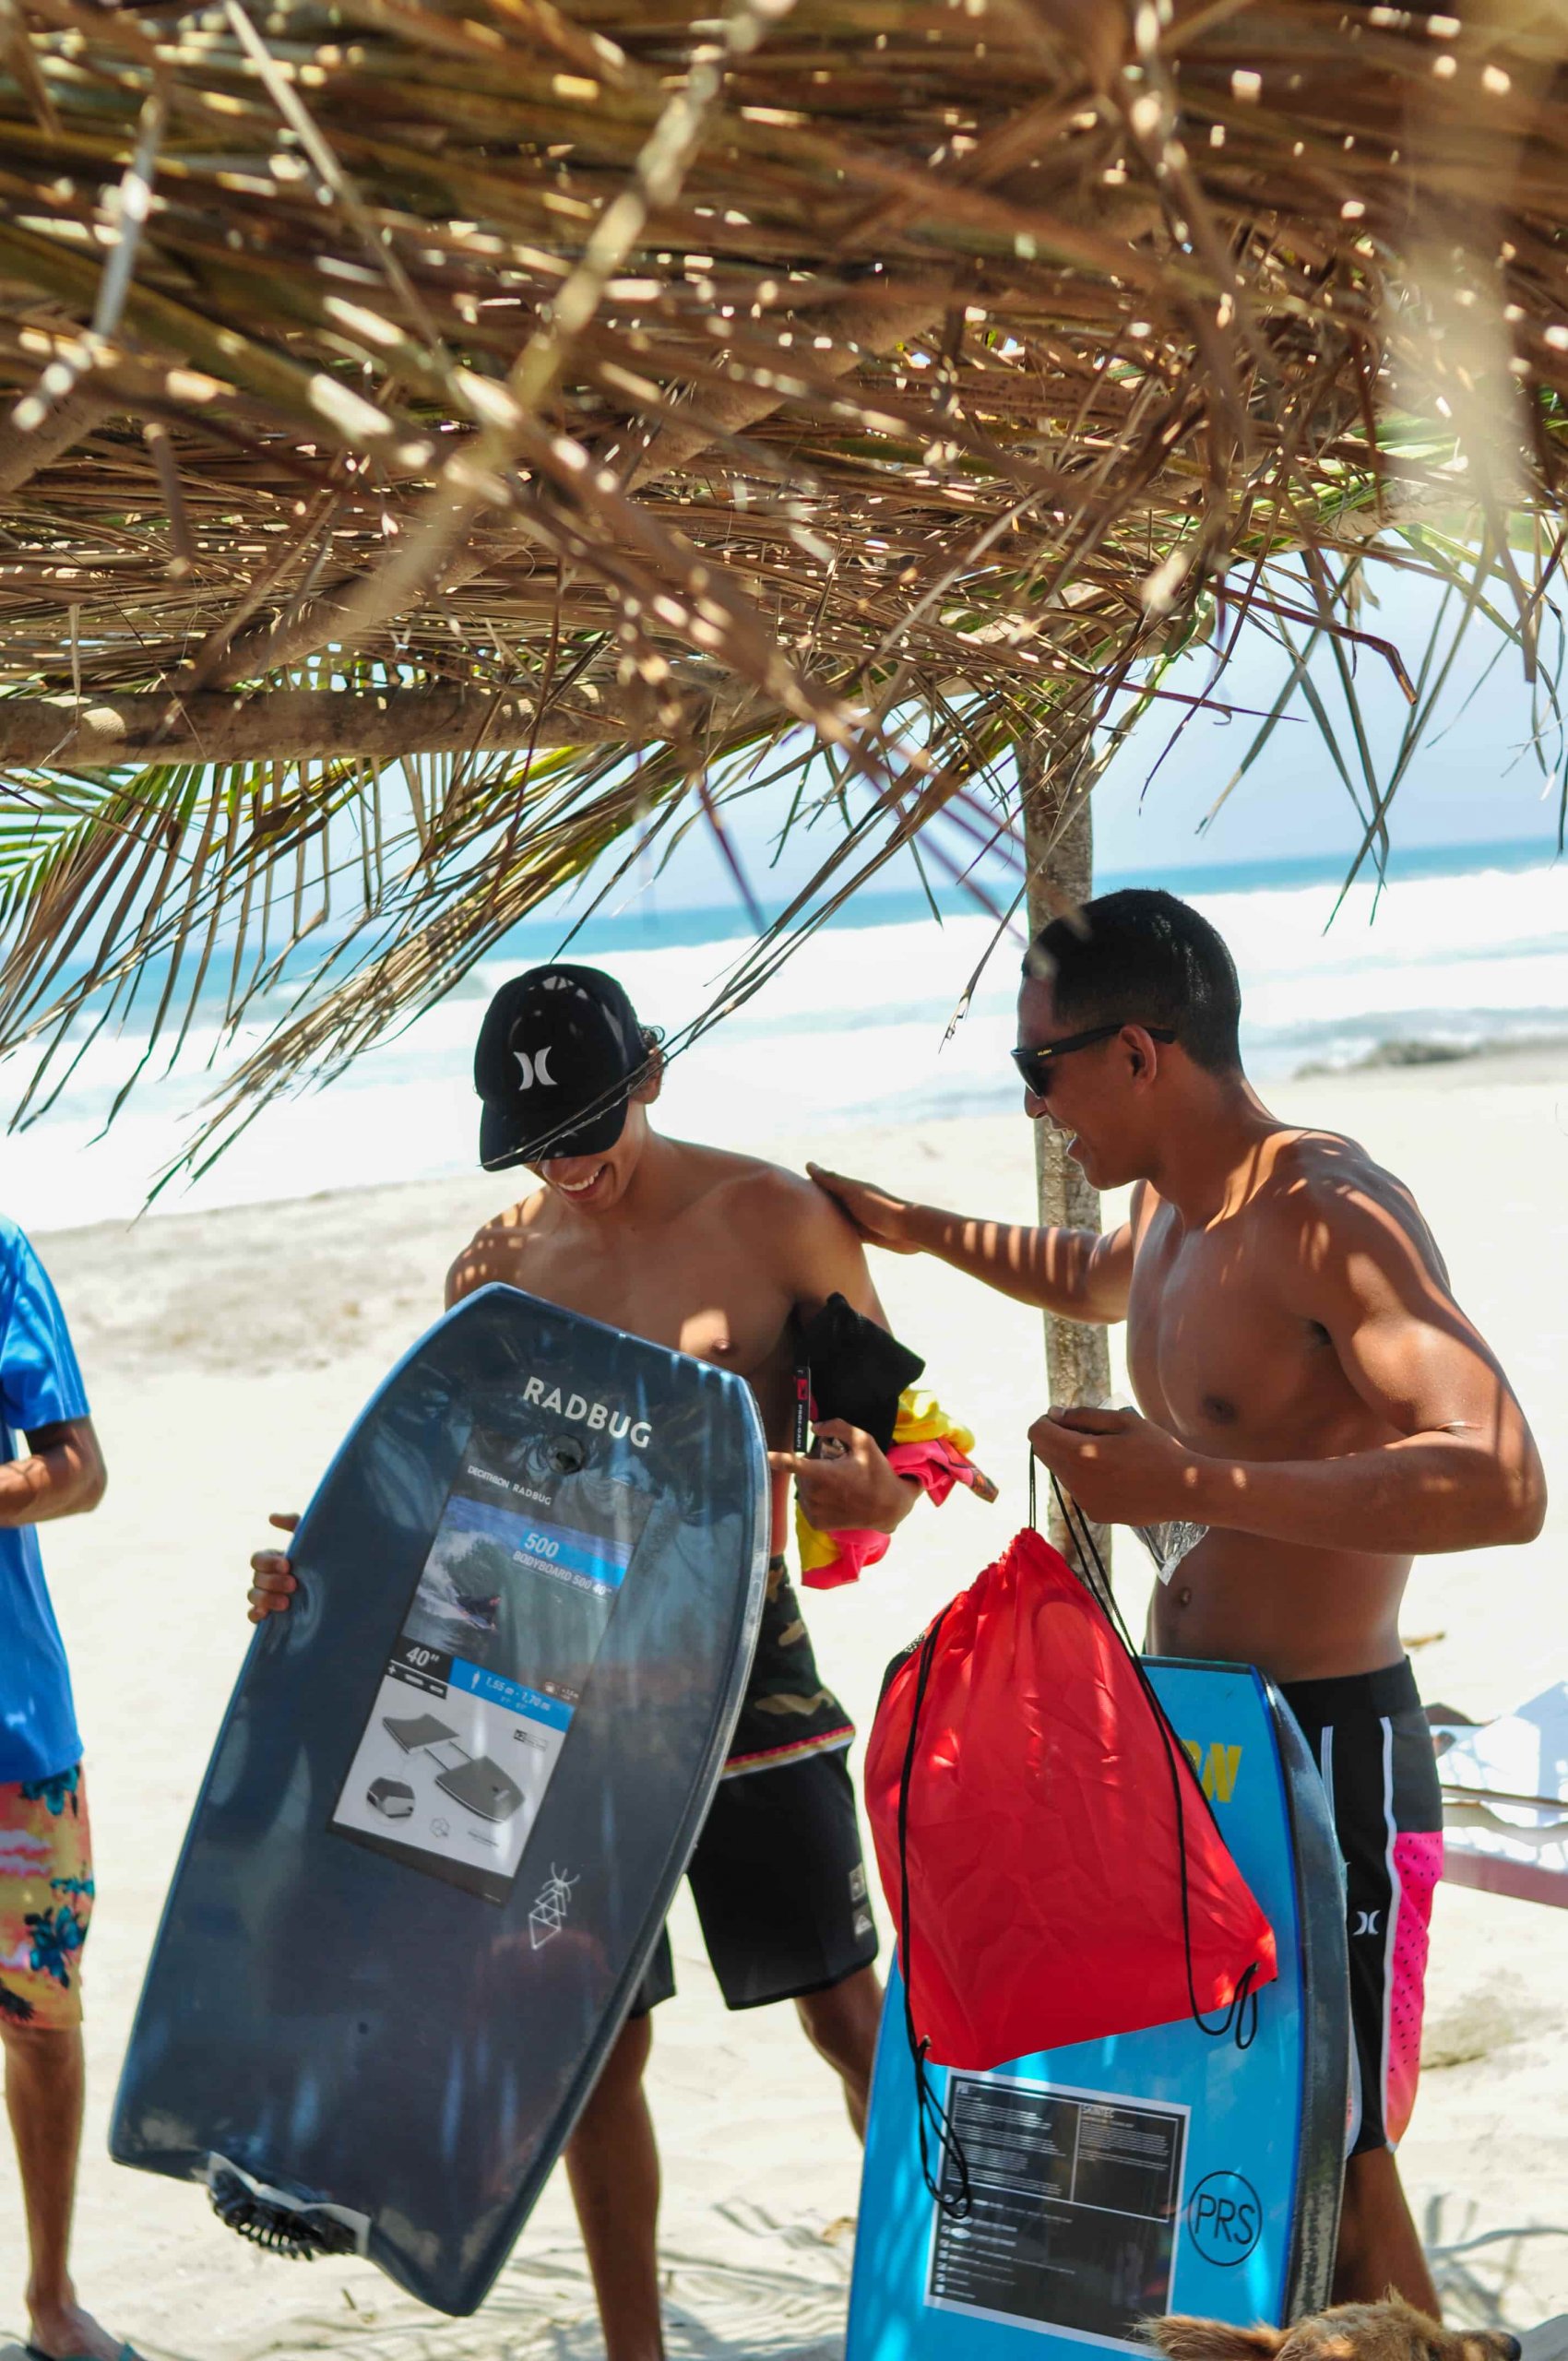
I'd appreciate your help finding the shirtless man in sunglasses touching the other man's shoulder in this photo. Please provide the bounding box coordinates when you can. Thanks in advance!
[813,890,1547,2311]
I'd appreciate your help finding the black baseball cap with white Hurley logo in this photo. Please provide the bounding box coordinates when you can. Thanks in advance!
[475,966,647,1173]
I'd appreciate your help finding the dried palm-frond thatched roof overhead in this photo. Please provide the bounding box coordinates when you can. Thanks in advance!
[0,0,1568,1180]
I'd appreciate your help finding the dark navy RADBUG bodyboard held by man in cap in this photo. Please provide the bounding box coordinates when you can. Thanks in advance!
[111,1287,770,2314]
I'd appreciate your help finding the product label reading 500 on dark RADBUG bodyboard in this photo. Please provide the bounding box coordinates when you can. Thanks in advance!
[330,1429,652,1901]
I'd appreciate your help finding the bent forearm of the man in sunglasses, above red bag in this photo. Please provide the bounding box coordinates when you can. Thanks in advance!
[1190,1433,1544,1559]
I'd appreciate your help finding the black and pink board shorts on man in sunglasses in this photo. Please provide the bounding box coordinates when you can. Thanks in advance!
[1280,1657,1443,2155]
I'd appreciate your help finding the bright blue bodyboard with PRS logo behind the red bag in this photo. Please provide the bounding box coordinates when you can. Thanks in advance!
[848,1660,1348,2361]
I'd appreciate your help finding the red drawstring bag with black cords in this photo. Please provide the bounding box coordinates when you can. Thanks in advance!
[867,1530,1277,2070]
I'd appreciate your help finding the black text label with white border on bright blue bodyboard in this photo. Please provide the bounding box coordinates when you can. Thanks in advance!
[926,2073,1188,2349]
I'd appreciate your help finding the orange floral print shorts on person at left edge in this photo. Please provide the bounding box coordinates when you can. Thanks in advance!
[0,1763,92,2025]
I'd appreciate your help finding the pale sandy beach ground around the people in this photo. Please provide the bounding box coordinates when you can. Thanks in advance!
[0,1050,1568,2361]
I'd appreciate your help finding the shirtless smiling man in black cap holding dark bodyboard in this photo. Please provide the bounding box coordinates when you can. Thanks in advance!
[250,966,916,2361]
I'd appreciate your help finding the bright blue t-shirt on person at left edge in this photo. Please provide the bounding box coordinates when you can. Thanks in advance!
[0,1214,88,1785]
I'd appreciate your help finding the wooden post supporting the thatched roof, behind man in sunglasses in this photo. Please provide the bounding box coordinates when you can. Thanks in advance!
[1017,732,1110,1570]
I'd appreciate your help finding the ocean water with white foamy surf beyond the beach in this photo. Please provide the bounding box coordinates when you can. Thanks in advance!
[0,845,1568,1230]
